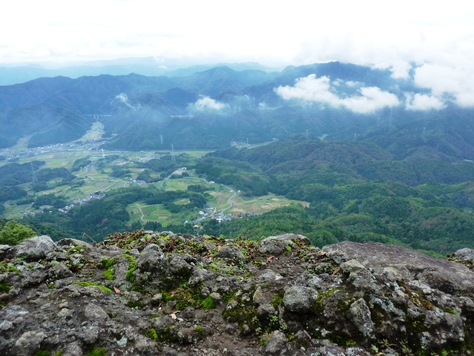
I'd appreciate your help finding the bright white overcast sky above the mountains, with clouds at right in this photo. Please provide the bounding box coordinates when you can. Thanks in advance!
[0,0,474,106]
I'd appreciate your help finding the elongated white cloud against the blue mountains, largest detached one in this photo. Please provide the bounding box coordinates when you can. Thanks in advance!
[275,74,400,114]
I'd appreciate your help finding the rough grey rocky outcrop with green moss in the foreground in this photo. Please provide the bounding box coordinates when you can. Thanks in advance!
[0,231,474,355]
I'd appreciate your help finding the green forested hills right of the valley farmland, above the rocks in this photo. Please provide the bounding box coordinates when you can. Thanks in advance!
[198,139,474,253]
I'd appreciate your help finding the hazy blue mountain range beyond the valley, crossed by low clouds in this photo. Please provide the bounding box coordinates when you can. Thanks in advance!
[0,62,474,159]
